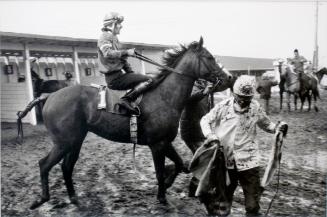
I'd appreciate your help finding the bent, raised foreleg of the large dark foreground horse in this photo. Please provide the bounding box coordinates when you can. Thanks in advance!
[165,143,189,189]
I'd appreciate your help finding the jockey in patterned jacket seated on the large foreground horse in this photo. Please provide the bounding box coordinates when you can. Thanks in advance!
[97,12,153,113]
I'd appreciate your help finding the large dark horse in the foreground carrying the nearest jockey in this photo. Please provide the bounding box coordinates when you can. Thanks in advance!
[31,38,230,209]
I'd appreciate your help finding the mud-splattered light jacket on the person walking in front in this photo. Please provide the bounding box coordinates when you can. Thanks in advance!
[200,97,276,171]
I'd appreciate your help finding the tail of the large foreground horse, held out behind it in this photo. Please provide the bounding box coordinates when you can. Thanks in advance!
[17,95,49,142]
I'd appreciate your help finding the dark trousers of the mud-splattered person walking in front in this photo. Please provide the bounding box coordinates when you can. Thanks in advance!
[226,167,263,216]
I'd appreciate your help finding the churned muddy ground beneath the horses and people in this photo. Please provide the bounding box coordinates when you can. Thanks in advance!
[1,91,327,217]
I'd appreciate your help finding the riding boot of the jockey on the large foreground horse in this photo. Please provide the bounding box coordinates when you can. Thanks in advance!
[118,78,153,114]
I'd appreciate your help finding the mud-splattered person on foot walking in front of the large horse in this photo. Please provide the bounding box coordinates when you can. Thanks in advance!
[200,75,286,216]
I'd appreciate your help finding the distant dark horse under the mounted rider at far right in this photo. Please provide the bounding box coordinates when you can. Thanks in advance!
[282,64,319,111]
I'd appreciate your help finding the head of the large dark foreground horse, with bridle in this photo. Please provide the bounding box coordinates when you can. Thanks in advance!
[166,37,233,83]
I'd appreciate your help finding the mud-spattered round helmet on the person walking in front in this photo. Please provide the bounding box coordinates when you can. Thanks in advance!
[233,75,256,96]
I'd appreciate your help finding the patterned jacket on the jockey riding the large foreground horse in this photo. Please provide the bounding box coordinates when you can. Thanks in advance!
[97,31,127,73]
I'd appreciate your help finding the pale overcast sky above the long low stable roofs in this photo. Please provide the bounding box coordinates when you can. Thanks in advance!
[0,0,327,66]
